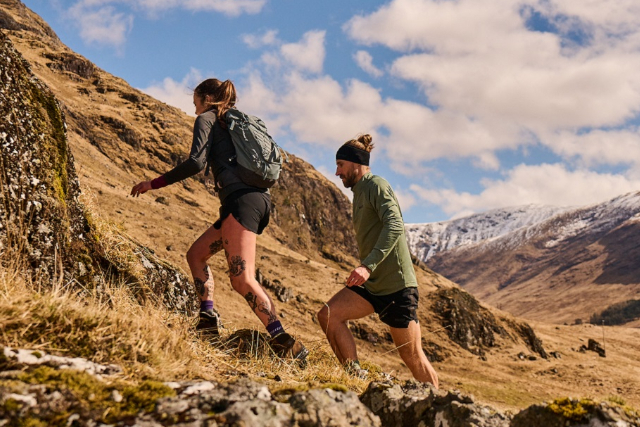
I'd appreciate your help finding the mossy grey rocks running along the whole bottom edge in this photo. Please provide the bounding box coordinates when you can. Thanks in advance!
[5,348,640,427]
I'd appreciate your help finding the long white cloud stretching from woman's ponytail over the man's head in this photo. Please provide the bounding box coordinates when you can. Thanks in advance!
[235,70,533,175]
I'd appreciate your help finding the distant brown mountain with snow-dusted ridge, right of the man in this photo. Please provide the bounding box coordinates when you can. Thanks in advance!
[407,193,640,322]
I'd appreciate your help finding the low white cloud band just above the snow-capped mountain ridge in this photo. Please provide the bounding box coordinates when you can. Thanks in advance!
[410,164,640,216]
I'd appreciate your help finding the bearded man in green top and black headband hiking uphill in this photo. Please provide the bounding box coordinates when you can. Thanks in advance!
[318,135,438,388]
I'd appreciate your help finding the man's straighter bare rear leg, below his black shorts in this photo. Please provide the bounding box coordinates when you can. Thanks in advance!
[390,320,438,388]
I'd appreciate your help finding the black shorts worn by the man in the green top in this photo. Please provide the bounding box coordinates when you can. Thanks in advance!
[349,286,419,329]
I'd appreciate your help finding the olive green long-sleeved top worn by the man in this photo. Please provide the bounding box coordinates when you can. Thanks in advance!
[351,172,418,295]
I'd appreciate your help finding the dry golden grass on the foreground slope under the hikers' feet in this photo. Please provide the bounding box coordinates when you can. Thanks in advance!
[0,198,379,392]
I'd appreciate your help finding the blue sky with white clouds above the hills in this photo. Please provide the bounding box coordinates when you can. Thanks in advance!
[24,0,640,223]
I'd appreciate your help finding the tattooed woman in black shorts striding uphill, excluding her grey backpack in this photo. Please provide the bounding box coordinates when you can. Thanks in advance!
[131,79,309,362]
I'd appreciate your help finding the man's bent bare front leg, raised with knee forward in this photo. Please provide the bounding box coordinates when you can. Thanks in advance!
[318,288,374,364]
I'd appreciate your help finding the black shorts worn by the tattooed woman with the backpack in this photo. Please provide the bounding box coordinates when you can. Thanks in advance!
[213,190,271,234]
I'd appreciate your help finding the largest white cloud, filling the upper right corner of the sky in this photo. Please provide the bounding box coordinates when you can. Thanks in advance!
[344,0,640,152]
